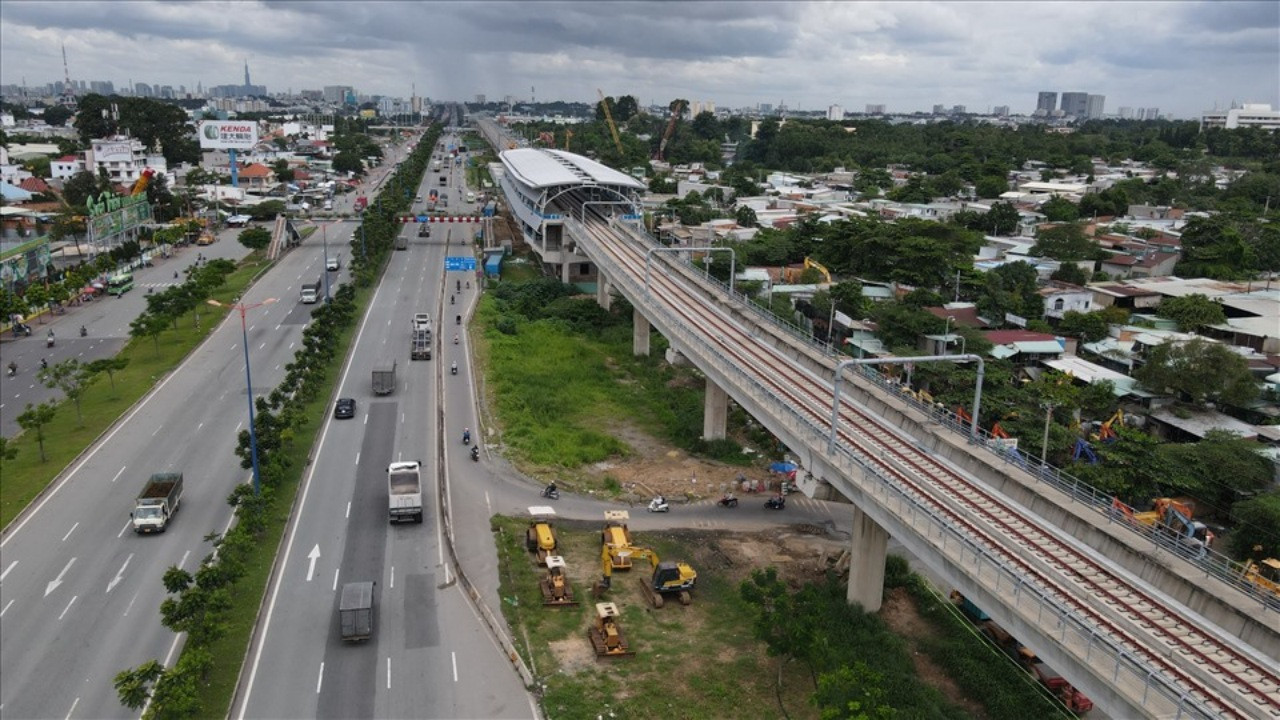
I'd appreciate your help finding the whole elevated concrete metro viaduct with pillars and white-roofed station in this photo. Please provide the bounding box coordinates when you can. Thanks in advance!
[491,142,1280,719]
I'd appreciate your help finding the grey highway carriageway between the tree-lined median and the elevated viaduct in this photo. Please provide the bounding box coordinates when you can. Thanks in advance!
[233,139,536,717]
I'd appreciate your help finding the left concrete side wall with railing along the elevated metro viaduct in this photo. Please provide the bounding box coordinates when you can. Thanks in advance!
[567,213,1219,719]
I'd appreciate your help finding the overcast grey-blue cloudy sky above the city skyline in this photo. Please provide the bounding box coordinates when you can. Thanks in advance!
[0,0,1280,118]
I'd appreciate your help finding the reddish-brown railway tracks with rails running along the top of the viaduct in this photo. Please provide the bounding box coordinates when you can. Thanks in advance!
[576,208,1280,719]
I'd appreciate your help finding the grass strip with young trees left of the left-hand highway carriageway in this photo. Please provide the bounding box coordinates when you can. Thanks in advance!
[0,252,270,527]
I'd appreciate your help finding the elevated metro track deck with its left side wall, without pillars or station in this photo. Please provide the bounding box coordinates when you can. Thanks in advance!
[566,198,1280,719]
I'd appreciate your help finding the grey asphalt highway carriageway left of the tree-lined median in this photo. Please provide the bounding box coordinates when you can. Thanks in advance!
[0,220,353,717]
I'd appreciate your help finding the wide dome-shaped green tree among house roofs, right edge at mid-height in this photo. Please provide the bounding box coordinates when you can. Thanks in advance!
[1134,337,1258,406]
